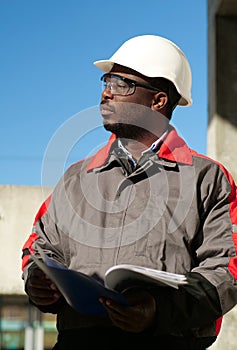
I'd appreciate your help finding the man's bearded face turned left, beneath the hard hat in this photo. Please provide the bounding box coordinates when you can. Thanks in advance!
[100,65,168,139]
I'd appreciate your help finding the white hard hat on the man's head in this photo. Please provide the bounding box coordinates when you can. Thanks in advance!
[94,35,192,106]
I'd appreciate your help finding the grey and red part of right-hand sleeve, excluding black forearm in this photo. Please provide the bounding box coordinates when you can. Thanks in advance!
[192,164,237,315]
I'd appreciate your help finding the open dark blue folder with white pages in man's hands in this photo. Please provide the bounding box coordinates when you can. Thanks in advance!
[31,247,187,314]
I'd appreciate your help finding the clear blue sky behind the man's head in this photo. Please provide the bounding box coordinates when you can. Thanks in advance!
[0,0,208,186]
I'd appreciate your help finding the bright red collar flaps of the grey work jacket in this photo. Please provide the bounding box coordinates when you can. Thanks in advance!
[86,126,193,171]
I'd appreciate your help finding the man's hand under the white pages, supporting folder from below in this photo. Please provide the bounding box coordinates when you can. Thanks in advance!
[100,289,156,333]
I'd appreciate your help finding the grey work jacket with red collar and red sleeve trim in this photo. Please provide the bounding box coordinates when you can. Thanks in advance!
[22,127,237,337]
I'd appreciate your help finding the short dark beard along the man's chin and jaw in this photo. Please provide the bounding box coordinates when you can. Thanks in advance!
[104,123,150,140]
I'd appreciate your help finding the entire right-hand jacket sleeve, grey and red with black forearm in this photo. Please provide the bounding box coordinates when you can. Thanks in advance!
[150,166,237,335]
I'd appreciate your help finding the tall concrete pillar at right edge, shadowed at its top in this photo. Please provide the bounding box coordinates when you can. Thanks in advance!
[207,0,237,350]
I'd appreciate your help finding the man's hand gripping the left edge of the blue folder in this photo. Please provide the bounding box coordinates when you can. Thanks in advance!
[25,267,61,306]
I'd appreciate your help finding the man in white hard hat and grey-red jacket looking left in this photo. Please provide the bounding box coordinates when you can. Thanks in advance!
[23,35,237,350]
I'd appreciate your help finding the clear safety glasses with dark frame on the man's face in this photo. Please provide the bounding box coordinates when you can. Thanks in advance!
[100,73,162,96]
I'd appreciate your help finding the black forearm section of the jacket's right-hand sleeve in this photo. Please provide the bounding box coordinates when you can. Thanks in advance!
[149,273,222,336]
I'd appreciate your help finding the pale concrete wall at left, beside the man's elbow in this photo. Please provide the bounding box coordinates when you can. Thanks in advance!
[0,185,51,294]
